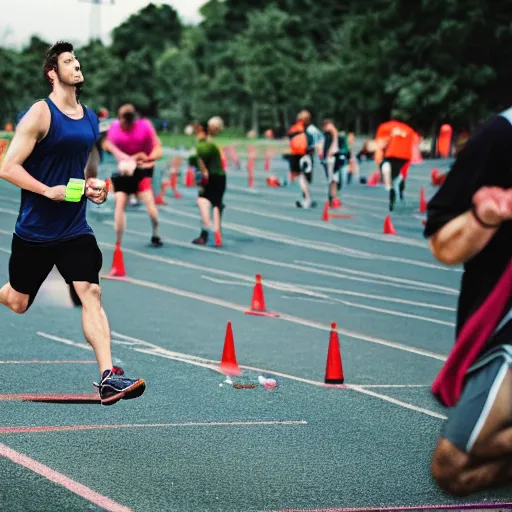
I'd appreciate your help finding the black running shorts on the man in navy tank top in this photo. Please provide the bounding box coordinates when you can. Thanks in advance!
[9,235,103,303]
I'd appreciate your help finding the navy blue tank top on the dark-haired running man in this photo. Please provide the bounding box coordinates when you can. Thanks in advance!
[15,98,99,243]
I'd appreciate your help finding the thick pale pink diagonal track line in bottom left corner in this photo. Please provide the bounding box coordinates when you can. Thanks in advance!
[0,443,133,512]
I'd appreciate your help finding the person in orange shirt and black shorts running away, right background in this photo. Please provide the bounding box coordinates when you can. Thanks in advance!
[376,120,415,211]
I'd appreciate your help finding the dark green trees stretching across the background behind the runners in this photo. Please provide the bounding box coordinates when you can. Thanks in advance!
[0,0,512,136]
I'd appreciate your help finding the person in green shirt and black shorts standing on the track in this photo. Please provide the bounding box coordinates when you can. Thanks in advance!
[192,117,226,247]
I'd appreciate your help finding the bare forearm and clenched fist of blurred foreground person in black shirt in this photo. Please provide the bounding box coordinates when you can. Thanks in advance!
[429,187,512,265]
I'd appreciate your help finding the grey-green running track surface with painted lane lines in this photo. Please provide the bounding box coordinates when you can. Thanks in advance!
[0,149,512,512]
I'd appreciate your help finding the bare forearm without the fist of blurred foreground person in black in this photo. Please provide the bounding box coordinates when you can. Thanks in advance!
[429,211,498,265]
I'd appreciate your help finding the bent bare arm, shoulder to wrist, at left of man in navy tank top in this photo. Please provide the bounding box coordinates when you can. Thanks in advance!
[0,101,51,196]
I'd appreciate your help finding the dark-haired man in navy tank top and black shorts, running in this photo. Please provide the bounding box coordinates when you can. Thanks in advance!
[0,42,146,405]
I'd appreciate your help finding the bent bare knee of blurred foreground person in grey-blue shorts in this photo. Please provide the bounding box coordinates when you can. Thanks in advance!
[431,439,472,496]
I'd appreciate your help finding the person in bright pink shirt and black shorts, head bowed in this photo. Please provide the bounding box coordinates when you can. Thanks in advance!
[103,104,163,247]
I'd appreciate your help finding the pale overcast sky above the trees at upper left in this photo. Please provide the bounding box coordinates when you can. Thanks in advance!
[0,0,206,47]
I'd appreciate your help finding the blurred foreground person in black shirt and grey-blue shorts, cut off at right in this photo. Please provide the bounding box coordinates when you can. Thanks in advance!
[425,109,512,496]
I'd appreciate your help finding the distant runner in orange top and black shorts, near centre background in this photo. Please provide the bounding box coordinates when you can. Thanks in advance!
[288,110,323,208]
